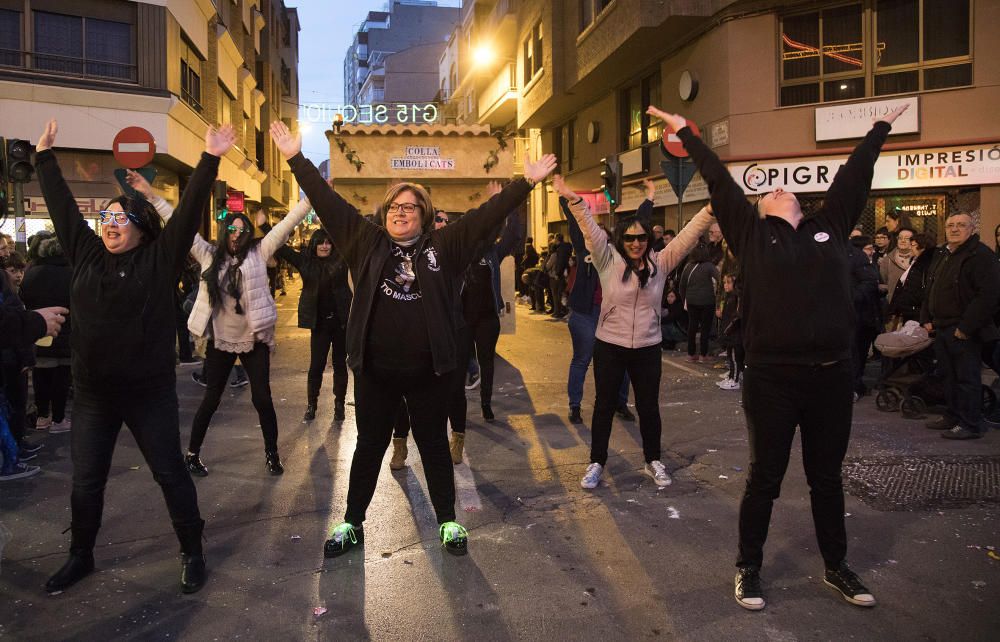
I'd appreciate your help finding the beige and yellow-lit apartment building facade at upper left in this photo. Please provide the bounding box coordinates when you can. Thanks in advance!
[0,0,298,240]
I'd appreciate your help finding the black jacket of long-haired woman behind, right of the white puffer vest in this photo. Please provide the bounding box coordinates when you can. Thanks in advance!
[275,243,354,329]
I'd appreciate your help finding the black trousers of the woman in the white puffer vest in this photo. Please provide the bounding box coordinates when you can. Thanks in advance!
[188,342,278,453]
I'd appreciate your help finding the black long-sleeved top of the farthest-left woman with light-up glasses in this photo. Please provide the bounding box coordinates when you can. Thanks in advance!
[35,150,219,390]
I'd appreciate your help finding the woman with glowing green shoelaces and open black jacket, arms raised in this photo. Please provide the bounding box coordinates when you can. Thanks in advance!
[271,121,556,557]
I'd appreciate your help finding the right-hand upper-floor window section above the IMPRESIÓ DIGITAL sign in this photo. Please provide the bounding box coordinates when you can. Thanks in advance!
[873,0,972,96]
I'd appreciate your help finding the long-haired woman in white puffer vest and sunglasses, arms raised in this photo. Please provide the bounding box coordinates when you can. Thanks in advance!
[128,172,310,477]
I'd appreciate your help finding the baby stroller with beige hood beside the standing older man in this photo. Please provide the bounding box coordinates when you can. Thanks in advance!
[875,321,997,419]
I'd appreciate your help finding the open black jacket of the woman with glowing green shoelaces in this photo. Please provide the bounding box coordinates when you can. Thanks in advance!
[288,154,531,375]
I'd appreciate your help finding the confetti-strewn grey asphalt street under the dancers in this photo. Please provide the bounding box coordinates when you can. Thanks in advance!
[0,281,1000,642]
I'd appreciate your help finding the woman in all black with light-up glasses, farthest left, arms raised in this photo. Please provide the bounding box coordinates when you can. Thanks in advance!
[35,120,236,593]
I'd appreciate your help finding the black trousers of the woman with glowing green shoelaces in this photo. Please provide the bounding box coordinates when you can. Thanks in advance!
[344,367,461,526]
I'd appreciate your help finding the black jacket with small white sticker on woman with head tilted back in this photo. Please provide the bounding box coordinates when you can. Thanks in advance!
[678,121,890,365]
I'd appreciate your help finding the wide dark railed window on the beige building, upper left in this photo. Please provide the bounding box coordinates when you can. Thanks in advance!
[33,11,136,82]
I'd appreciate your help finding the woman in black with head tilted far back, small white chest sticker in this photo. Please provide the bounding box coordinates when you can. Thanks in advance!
[648,105,907,610]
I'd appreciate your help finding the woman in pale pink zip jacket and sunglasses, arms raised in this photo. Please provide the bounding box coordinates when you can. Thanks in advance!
[553,176,714,488]
